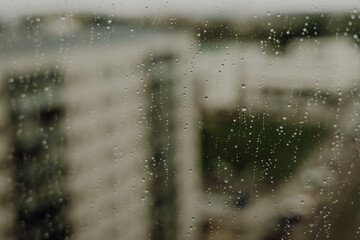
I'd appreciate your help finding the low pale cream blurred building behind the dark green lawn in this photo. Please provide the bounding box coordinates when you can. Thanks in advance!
[195,37,360,122]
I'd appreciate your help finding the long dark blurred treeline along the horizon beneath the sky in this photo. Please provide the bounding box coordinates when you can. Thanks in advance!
[9,10,360,53]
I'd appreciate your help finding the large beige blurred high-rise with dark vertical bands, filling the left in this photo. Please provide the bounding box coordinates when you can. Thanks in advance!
[0,18,200,240]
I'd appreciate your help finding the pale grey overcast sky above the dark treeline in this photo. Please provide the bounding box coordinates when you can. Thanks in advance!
[0,0,360,17]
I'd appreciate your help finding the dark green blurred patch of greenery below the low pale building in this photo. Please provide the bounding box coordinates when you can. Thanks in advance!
[202,113,325,183]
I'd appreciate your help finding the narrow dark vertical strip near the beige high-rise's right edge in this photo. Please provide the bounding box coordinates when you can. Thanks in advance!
[148,56,177,240]
